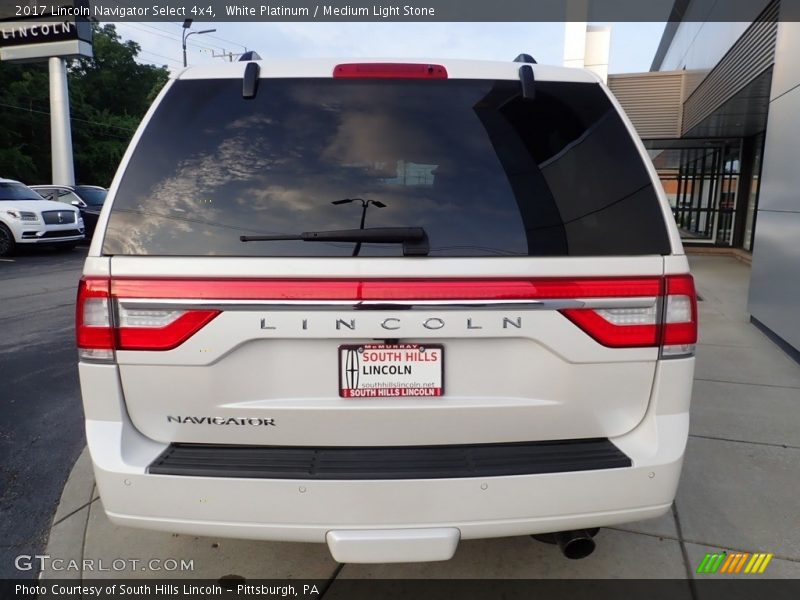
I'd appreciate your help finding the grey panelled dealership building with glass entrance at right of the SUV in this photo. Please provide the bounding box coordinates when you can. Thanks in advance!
[608,0,800,358]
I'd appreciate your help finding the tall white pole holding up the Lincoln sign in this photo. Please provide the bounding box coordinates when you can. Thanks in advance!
[49,57,75,185]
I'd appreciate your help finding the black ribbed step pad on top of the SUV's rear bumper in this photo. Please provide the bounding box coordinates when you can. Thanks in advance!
[148,438,631,480]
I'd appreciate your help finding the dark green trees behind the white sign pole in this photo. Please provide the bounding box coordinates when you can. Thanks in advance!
[0,25,169,186]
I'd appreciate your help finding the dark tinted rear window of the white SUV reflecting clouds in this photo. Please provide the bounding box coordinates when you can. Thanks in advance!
[103,79,670,257]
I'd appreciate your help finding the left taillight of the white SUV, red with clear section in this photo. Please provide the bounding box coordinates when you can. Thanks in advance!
[75,277,219,360]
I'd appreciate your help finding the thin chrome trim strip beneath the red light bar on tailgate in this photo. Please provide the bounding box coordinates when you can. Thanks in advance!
[117,297,657,311]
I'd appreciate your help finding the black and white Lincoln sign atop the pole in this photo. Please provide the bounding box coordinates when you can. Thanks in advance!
[0,0,92,61]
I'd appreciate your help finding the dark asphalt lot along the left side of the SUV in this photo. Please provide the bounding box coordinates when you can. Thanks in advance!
[0,246,87,579]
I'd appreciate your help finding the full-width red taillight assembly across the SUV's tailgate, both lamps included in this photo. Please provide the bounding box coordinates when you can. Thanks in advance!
[76,275,697,359]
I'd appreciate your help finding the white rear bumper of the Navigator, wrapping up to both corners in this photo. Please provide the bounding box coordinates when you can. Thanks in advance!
[81,359,694,562]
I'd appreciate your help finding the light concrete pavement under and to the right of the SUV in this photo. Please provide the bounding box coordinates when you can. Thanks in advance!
[3,256,800,580]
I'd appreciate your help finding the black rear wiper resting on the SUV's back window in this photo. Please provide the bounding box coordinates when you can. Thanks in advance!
[239,227,430,256]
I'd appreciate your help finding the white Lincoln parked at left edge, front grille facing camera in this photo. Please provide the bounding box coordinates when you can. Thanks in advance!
[0,179,84,256]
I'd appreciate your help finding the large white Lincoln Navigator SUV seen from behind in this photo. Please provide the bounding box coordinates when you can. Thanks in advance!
[77,60,697,562]
